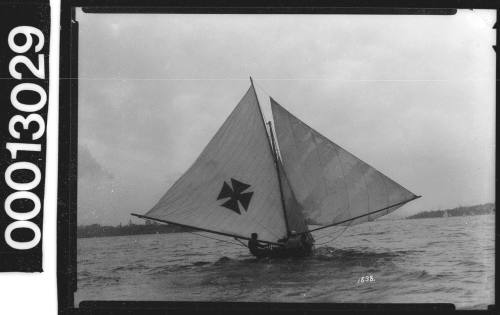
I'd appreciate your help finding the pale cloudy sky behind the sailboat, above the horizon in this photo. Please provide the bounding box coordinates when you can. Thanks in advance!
[77,10,496,225]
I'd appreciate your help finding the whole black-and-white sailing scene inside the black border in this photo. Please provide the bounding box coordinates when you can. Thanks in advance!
[74,8,497,310]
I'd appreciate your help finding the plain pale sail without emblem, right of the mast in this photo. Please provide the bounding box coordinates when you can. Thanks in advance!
[271,98,417,226]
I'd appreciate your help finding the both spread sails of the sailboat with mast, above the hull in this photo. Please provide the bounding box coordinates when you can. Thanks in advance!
[132,78,420,258]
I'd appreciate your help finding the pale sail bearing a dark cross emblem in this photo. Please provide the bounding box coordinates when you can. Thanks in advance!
[145,86,287,242]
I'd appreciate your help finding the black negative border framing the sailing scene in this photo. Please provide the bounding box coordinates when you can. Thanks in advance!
[57,0,498,314]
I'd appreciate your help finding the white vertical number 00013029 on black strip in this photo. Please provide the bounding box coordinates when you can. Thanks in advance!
[4,26,47,250]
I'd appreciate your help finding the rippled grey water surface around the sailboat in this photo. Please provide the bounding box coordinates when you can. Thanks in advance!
[75,215,495,309]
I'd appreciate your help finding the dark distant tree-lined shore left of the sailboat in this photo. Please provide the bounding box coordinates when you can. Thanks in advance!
[76,220,194,238]
